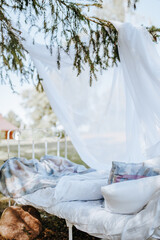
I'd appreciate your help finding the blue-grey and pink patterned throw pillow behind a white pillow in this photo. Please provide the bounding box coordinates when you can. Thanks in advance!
[108,162,160,184]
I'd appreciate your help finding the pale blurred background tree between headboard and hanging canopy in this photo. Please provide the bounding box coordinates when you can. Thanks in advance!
[22,89,57,128]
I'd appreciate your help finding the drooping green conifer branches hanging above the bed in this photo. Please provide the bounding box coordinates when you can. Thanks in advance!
[0,0,156,88]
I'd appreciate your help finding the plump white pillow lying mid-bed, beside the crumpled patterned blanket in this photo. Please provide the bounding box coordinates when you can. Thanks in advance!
[54,172,108,202]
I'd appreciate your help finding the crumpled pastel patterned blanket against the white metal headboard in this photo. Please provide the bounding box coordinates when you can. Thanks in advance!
[0,155,86,198]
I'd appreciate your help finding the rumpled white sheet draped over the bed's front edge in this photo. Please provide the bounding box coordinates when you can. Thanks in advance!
[15,173,160,240]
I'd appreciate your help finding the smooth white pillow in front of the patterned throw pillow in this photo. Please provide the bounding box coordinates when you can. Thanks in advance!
[101,175,160,214]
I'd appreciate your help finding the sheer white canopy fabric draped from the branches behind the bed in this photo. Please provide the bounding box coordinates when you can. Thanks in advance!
[23,23,160,170]
